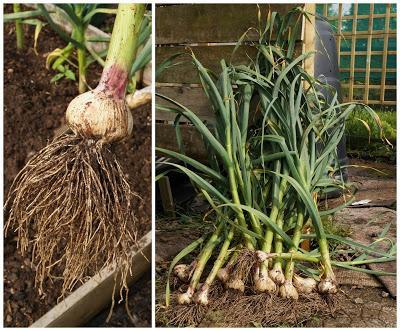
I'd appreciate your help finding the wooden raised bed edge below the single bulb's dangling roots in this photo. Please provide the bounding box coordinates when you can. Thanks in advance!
[30,231,151,328]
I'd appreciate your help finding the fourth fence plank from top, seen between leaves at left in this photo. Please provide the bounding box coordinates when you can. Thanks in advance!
[156,123,207,161]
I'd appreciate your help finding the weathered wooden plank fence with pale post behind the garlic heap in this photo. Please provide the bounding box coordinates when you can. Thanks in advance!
[155,3,315,158]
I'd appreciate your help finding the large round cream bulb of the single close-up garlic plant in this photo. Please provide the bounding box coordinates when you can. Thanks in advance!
[66,88,133,143]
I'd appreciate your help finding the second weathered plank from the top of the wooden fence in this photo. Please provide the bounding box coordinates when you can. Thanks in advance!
[156,42,302,84]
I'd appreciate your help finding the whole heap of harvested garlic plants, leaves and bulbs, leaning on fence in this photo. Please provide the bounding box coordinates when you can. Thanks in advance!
[156,8,395,323]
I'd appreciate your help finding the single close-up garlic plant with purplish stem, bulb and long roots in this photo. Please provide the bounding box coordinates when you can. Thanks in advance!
[5,4,145,295]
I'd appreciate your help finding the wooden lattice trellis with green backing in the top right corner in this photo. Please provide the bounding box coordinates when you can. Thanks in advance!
[318,3,397,105]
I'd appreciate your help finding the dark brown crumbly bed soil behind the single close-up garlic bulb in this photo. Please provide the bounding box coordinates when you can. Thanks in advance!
[4,6,151,327]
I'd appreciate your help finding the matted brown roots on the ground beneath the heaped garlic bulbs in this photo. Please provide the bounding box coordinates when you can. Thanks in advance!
[157,284,340,327]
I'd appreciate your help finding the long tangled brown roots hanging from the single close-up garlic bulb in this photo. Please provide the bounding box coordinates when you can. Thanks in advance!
[5,133,139,295]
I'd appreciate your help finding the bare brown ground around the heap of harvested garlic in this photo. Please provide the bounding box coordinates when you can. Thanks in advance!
[156,159,396,327]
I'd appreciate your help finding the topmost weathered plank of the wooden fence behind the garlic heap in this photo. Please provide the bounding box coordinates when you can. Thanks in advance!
[155,3,300,44]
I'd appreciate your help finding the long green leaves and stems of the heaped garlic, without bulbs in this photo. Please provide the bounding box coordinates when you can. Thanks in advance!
[156,7,394,306]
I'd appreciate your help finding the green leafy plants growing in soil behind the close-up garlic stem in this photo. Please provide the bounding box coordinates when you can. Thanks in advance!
[4,4,151,93]
